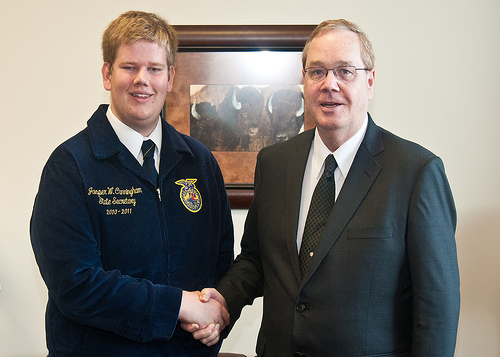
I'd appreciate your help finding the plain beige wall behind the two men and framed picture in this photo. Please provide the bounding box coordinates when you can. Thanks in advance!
[0,0,500,357]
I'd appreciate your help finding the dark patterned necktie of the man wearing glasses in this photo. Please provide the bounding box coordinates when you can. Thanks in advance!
[299,154,337,276]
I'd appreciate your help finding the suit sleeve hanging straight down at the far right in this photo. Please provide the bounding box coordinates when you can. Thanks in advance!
[407,157,460,357]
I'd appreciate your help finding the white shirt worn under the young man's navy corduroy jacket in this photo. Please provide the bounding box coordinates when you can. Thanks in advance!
[106,106,162,172]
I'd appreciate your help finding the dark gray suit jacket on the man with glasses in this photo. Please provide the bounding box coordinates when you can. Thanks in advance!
[218,114,460,357]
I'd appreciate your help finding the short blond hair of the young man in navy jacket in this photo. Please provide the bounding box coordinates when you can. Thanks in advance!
[102,11,178,68]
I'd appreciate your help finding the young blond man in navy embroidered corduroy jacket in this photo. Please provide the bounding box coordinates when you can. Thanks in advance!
[31,11,233,356]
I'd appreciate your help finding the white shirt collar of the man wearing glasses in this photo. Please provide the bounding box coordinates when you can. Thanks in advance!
[311,114,368,179]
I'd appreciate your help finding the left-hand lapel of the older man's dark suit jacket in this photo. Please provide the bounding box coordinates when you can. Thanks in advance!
[284,130,314,282]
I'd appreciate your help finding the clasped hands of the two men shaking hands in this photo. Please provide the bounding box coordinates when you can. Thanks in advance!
[179,288,229,346]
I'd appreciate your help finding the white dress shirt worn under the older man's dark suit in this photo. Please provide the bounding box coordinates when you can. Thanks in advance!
[297,115,368,252]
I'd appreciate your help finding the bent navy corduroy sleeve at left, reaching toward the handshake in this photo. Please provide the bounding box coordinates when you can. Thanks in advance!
[30,155,182,342]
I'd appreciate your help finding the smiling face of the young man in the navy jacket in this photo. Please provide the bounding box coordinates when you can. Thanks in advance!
[102,40,174,136]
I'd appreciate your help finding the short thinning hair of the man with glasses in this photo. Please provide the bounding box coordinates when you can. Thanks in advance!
[302,19,375,70]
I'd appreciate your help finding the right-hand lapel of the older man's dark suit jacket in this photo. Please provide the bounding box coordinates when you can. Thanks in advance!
[301,117,383,288]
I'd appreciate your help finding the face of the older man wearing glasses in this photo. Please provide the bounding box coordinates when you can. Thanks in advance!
[303,29,375,151]
